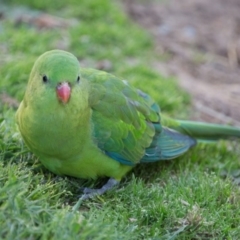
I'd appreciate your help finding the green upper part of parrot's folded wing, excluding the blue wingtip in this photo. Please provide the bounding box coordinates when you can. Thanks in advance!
[83,69,160,165]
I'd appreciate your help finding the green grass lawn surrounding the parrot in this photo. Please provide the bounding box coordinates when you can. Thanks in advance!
[0,0,240,240]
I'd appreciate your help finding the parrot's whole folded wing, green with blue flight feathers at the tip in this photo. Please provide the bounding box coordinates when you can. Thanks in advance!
[82,69,195,166]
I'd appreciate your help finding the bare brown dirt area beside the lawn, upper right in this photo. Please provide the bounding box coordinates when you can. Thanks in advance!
[124,0,240,125]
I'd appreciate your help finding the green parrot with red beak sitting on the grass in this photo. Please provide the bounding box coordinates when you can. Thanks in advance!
[16,50,240,199]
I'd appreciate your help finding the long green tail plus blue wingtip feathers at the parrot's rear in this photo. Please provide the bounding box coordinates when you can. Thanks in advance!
[141,119,240,162]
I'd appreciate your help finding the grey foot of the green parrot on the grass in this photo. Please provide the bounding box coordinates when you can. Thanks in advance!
[80,178,119,200]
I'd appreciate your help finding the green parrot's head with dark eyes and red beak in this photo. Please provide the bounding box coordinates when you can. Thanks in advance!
[25,50,88,109]
